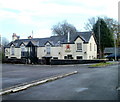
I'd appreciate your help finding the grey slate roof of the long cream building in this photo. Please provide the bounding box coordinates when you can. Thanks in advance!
[6,32,93,47]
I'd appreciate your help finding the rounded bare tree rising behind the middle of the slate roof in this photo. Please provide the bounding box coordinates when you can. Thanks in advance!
[52,21,77,36]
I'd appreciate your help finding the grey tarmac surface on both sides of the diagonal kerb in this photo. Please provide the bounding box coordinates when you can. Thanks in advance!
[3,64,119,100]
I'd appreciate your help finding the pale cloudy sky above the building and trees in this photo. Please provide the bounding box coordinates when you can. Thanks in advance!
[0,0,119,41]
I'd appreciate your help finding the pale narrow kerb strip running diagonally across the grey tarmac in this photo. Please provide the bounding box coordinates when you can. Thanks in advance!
[0,71,78,95]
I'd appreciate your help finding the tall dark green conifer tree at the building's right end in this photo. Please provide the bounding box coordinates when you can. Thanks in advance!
[93,18,114,57]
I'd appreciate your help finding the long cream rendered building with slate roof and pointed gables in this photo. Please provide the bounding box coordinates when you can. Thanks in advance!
[5,32,97,63]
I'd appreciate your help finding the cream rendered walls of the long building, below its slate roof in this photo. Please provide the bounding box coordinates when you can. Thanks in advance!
[5,35,97,59]
